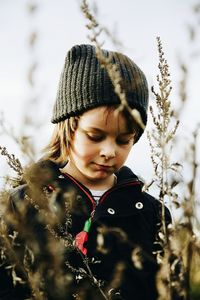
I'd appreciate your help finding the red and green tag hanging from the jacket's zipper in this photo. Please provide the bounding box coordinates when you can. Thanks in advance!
[75,218,92,255]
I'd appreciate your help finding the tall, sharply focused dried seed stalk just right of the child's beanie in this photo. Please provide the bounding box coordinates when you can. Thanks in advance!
[148,37,184,300]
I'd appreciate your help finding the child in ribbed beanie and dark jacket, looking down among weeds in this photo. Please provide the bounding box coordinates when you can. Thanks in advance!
[0,45,170,300]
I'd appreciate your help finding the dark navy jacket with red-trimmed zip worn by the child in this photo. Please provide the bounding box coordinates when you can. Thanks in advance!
[0,161,171,300]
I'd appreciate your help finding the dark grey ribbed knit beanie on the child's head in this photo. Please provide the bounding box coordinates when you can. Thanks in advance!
[52,45,148,139]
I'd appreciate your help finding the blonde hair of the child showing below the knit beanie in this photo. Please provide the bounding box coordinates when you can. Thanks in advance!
[44,105,141,166]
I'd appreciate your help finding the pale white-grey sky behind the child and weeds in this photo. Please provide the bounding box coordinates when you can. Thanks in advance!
[0,0,200,199]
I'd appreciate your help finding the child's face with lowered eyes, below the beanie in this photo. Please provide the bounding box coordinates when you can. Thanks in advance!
[63,107,134,190]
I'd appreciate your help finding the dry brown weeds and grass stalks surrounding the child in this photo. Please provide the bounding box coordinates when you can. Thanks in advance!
[0,1,200,300]
